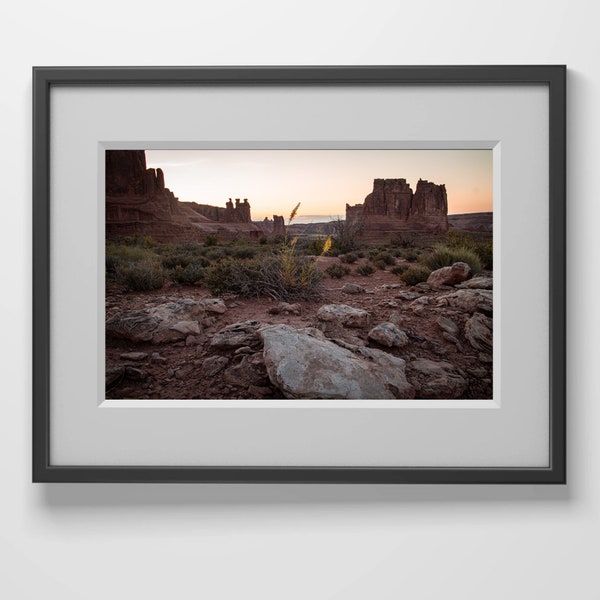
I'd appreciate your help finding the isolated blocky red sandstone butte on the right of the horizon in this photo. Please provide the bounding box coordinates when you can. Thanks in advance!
[346,179,448,240]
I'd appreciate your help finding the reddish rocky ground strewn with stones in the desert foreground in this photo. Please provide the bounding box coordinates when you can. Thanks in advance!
[106,257,493,399]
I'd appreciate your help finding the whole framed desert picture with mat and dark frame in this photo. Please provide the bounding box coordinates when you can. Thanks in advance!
[33,65,566,484]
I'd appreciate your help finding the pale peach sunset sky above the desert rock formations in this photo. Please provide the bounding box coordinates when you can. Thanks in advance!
[146,150,492,220]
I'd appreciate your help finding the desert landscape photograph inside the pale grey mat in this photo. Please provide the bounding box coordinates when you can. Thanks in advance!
[105,149,494,400]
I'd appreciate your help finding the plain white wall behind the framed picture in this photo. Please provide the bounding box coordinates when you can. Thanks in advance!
[0,0,600,600]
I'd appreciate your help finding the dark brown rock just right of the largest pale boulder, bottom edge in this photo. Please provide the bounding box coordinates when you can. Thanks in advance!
[407,358,467,399]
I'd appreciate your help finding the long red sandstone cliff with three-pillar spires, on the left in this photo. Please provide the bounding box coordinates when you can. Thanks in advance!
[105,150,283,242]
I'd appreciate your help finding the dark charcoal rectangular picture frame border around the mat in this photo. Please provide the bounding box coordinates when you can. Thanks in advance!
[33,65,566,484]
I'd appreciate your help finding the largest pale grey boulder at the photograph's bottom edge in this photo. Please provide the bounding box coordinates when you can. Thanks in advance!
[259,325,413,399]
